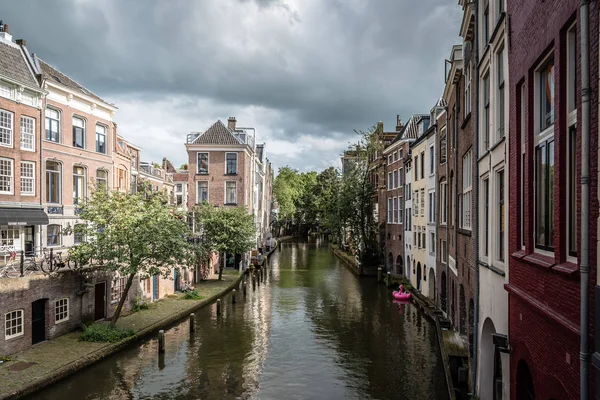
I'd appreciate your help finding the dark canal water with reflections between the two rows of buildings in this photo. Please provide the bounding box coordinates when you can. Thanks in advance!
[31,240,448,400]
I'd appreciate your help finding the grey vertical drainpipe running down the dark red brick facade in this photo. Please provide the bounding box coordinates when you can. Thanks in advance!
[579,0,591,400]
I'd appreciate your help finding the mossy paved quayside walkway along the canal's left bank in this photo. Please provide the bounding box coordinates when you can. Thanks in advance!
[0,271,242,400]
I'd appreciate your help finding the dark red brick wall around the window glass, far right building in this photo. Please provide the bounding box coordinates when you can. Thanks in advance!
[506,0,598,399]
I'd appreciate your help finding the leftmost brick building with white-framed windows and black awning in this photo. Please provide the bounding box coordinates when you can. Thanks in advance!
[0,25,48,256]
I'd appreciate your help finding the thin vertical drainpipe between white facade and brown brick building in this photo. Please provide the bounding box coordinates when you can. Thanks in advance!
[471,0,479,394]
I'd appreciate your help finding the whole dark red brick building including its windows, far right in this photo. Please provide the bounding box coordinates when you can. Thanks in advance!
[506,0,599,399]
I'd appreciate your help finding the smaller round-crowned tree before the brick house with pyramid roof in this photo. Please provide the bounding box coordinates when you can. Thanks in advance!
[195,203,256,280]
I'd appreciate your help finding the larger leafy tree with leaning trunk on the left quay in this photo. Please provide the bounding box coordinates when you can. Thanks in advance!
[69,188,193,326]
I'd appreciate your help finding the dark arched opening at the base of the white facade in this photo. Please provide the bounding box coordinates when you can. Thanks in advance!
[479,318,502,400]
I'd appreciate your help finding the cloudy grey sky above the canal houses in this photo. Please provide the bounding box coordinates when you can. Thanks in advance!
[0,0,461,170]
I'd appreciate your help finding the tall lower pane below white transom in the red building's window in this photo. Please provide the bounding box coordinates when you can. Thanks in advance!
[534,140,554,250]
